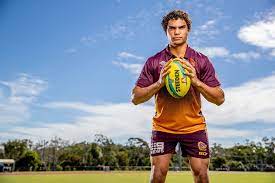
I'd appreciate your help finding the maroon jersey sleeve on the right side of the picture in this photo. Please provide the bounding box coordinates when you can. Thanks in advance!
[200,57,221,87]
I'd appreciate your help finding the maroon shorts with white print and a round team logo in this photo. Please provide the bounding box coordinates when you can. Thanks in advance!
[150,130,209,159]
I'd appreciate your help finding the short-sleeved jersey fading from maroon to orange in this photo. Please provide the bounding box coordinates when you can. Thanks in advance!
[136,46,220,134]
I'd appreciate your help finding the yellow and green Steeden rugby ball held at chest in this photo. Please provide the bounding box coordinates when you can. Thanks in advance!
[165,59,191,98]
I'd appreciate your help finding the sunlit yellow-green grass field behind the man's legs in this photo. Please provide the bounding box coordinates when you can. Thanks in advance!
[0,171,275,183]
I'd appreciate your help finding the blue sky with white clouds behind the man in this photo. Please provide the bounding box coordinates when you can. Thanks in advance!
[0,0,275,146]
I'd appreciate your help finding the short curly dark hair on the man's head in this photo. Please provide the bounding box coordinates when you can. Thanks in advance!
[161,10,192,33]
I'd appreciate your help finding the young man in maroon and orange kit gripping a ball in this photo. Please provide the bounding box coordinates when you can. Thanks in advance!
[132,10,224,183]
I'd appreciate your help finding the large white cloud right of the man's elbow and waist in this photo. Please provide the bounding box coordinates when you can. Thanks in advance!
[203,74,275,125]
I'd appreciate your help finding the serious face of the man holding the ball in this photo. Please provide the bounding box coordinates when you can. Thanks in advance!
[166,18,189,46]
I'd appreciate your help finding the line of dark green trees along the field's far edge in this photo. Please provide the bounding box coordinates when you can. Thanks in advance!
[0,134,275,171]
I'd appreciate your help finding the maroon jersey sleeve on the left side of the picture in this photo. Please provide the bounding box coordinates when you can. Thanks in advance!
[136,58,154,88]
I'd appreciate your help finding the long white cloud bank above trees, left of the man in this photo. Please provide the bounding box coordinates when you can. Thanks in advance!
[0,102,154,141]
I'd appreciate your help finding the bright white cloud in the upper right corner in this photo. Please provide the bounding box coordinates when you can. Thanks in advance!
[238,10,275,48]
